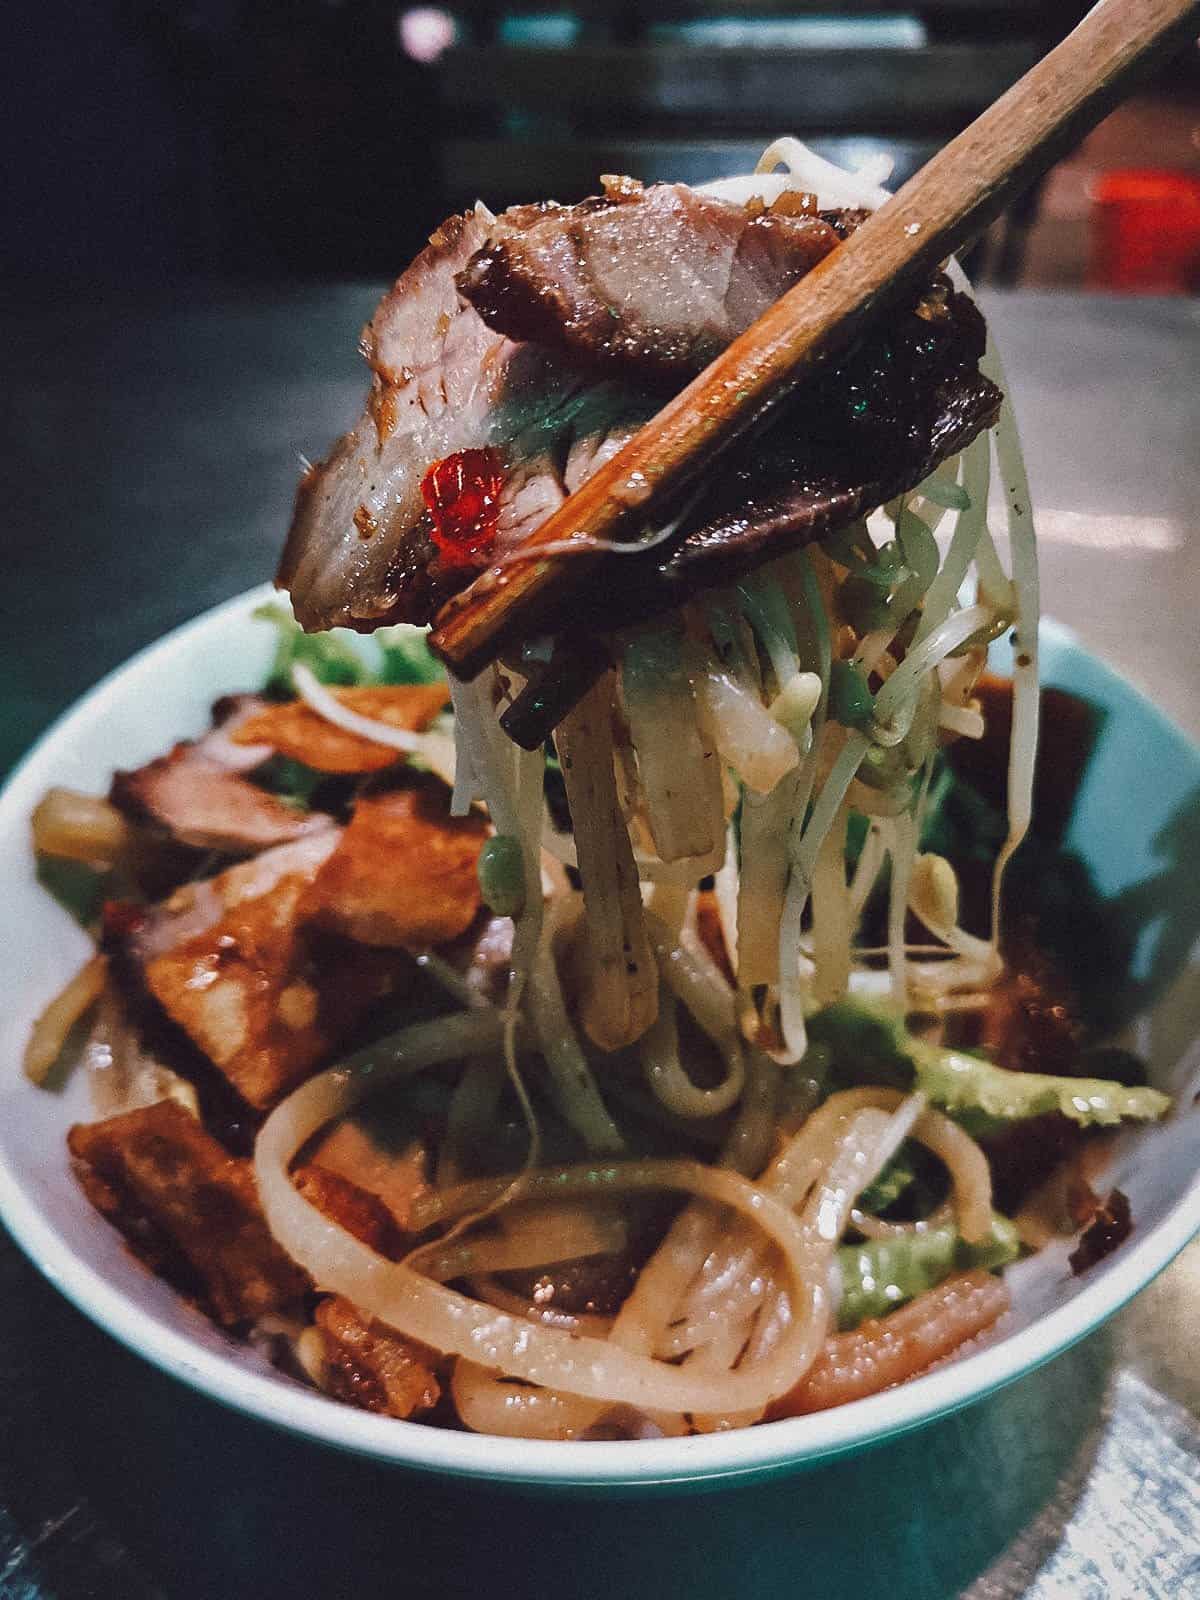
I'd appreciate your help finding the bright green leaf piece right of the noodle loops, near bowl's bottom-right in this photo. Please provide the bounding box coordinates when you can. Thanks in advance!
[837,1213,1021,1330]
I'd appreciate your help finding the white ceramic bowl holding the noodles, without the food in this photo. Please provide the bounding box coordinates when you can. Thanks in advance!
[0,590,1200,1488]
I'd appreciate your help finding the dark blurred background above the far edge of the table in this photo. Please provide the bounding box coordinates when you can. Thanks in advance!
[0,0,1200,293]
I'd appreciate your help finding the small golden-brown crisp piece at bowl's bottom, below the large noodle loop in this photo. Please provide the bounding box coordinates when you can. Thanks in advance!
[317,1296,442,1418]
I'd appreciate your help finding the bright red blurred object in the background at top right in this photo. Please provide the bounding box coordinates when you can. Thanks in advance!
[1088,168,1200,294]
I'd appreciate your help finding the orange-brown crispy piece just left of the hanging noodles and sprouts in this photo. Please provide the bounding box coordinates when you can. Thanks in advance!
[301,781,488,950]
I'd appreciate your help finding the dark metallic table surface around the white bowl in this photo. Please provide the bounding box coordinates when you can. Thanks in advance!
[0,285,1200,1600]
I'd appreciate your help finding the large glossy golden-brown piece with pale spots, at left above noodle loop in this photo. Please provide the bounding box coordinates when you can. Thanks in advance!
[142,850,410,1110]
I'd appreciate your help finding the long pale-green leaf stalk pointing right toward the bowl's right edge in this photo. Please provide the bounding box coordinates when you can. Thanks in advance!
[808,1000,1171,1128]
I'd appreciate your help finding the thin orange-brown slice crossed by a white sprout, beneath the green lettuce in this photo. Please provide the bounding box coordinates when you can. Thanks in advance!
[232,683,450,773]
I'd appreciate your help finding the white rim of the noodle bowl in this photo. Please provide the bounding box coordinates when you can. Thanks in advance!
[0,584,1200,1488]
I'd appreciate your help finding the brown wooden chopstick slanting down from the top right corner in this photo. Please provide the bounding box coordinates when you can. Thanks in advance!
[430,0,1200,686]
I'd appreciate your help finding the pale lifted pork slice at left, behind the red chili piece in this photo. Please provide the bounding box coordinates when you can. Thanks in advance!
[278,208,654,632]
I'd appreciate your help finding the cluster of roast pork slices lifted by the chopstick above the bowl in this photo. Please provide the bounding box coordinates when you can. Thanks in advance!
[278,182,1000,630]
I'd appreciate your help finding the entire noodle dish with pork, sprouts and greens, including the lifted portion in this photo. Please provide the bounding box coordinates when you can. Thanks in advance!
[27,141,1170,1440]
